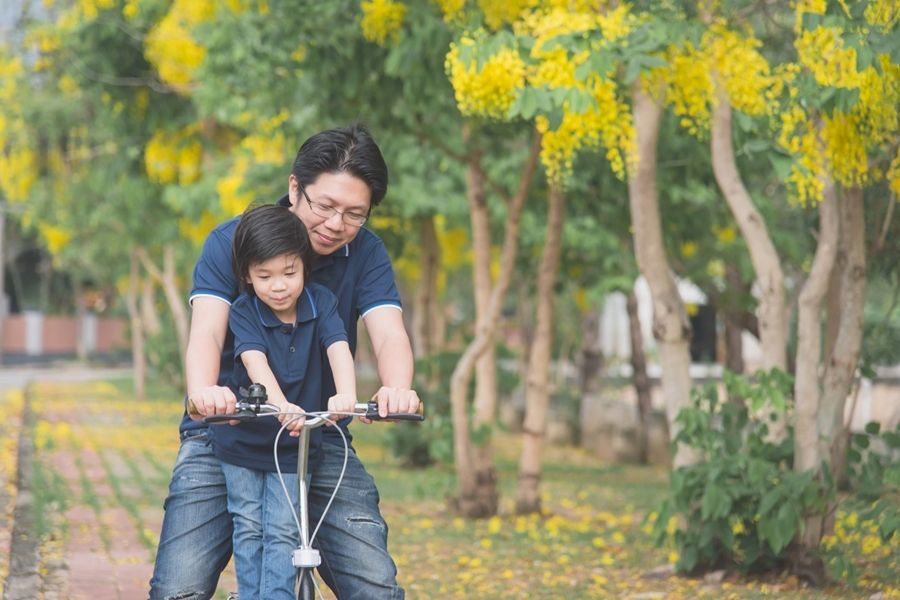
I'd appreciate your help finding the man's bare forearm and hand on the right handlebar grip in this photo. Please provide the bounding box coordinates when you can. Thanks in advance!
[363,306,419,417]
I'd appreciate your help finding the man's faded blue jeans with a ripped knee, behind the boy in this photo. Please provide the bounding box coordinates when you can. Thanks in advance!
[150,430,404,600]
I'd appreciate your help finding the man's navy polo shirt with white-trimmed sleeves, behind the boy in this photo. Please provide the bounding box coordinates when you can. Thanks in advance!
[181,196,400,444]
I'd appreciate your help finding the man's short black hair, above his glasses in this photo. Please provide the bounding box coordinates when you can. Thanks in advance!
[291,123,388,207]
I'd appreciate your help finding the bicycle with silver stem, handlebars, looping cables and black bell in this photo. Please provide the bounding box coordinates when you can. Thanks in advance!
[187,383,425,600]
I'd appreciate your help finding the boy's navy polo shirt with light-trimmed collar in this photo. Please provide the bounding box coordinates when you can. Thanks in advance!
[210,284,347,472]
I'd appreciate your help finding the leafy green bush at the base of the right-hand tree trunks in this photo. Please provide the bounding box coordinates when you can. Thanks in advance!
[654,372,829,573]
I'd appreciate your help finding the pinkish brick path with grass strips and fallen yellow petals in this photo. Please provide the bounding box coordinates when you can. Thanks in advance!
[0,372,236,600]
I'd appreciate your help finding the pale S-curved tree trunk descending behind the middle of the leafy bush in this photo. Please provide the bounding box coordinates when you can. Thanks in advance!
[711,84,788,440]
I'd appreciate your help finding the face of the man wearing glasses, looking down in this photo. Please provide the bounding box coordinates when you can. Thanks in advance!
[288,173,372,255]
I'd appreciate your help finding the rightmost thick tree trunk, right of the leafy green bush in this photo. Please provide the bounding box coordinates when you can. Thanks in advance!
[819,188,866,496]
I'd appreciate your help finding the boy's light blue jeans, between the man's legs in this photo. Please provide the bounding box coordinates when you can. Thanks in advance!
[222,463,299,600]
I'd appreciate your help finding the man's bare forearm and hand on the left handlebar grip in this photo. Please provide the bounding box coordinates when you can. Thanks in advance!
[185,296,235,420]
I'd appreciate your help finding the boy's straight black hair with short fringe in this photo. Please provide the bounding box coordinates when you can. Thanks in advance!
[231,204,316,292]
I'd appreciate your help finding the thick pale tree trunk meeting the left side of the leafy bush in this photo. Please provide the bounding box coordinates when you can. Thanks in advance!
[628,82,695,467]
